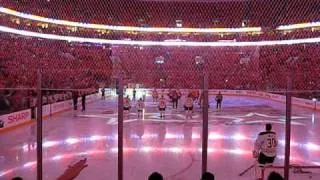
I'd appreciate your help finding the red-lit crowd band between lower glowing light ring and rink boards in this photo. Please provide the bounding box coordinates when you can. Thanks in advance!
[0,31,320,110]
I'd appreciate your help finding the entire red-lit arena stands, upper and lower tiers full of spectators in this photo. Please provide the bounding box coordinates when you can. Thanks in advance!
[0,0,320,110]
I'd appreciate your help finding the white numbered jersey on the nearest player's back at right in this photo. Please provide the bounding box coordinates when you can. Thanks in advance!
[254,131,278,157]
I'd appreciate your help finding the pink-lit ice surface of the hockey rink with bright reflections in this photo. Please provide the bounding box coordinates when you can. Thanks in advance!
[0,96,320,180]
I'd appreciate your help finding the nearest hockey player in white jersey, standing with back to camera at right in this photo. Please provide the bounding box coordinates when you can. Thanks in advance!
[253,124,278,179]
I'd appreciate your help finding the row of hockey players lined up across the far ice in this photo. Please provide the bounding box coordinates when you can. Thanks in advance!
[123,89,223,119]
